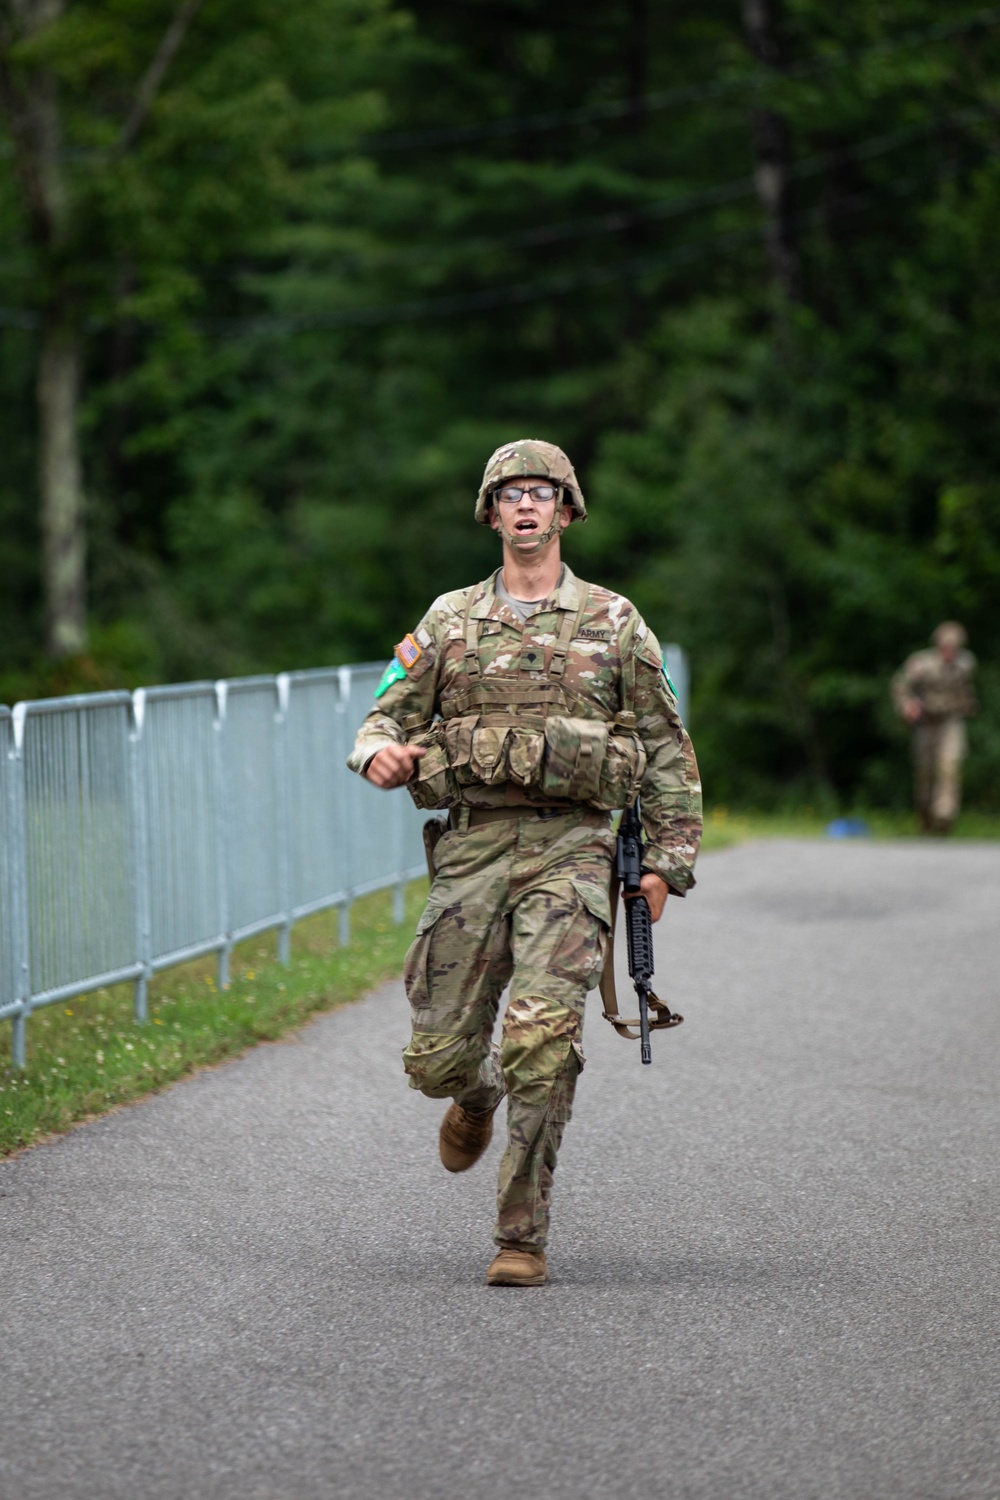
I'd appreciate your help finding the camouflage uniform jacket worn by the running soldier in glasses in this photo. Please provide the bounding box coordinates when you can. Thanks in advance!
[348,567,702,896]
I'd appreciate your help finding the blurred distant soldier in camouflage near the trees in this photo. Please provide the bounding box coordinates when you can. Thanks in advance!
[892,620,976,834]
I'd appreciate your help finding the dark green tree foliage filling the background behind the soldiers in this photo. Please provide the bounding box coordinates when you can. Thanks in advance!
[0,0,1000,801]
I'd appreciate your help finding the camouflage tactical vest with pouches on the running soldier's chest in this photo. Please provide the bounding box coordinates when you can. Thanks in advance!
[403,584,646,812]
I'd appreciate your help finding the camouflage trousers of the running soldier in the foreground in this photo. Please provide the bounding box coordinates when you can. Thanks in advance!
[403,809,615,1250]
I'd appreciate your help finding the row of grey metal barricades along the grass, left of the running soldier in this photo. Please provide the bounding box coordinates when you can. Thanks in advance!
[0,666,424,1067]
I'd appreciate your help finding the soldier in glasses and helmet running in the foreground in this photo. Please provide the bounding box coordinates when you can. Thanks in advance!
[348,440,702,1286]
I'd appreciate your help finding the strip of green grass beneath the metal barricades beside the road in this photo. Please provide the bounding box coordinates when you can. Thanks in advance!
[0,881,426,1157]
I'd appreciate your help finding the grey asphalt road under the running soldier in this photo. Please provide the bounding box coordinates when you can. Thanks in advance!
[0,842,1000,1500]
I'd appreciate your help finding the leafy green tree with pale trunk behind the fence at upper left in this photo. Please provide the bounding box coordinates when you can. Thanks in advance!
[0,0,397,672]
